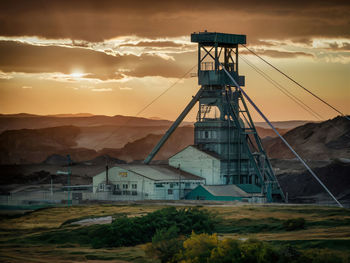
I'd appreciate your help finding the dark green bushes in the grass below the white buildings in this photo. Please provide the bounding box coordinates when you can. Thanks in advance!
[22,207,216,248]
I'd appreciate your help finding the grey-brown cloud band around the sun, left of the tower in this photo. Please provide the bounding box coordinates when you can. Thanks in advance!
[0,41,190,80]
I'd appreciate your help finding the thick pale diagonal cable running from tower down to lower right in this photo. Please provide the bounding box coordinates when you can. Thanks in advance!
[221,64,343,207]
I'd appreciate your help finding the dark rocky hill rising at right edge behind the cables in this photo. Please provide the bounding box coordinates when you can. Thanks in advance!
[263,117,350,160]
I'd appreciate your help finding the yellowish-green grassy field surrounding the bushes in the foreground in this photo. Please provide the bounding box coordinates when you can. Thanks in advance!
[0,204,350,262]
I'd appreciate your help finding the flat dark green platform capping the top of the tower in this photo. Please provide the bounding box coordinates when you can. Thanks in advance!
[191,32,246,46]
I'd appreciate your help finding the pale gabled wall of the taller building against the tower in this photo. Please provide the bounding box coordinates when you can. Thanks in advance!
[169,146,225,185]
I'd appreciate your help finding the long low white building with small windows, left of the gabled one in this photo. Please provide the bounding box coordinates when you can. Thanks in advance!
[93,164,205,200]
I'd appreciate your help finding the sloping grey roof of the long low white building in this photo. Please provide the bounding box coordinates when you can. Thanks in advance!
[112,164,204,181]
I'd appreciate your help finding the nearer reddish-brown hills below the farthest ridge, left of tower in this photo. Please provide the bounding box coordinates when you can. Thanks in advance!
[0,122,284,164]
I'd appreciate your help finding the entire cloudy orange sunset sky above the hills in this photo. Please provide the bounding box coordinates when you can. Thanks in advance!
[0,0,350,121]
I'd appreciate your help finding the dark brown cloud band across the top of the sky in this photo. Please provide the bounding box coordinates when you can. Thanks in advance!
[0,0,350,42]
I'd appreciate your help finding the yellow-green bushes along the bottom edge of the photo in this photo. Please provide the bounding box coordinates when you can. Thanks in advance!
[146,232,348,263]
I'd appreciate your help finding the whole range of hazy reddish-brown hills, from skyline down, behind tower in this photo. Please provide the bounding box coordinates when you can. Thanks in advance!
[0,114,287,164]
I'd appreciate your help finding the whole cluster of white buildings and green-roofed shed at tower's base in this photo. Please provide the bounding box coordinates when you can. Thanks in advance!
[93,145,263,202]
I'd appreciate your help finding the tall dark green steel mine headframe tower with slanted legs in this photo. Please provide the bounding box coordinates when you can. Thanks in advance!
[145,32,284,202]
